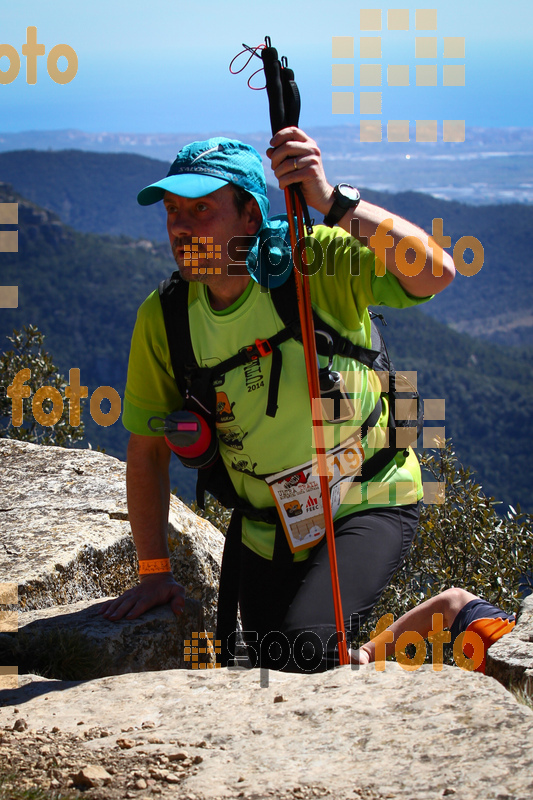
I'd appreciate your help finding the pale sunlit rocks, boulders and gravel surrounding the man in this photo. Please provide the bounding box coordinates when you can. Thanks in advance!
[0,440,533,800]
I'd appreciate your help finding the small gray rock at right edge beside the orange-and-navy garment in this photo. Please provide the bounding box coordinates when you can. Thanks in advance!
[485,594,533,697]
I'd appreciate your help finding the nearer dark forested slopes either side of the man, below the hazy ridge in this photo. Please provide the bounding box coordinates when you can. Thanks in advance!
[0,187,533,509]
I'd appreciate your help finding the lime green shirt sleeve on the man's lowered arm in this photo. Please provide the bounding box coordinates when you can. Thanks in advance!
[122,291,182,436]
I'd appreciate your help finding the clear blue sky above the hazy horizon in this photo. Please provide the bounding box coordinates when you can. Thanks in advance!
[0,0,533,132]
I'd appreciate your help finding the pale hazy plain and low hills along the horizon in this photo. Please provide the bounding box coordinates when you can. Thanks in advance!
[0,124,533,205]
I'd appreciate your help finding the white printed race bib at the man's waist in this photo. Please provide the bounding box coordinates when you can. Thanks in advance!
[265,437,364,553]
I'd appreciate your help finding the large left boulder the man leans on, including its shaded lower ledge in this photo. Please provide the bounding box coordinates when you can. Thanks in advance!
[0,439,224,683]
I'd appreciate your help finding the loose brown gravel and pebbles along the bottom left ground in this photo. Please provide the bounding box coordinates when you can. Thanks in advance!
[0,715,378,800]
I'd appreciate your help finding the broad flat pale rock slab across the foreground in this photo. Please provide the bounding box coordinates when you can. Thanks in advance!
[0,663,533,800]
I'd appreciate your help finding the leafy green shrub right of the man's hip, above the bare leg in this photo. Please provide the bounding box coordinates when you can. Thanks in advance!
[376,440,533,617]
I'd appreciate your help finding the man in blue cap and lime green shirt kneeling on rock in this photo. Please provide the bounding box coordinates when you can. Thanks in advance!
[98,128,455,672]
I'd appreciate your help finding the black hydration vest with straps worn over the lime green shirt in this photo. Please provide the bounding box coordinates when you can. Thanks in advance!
[159,271,423,523]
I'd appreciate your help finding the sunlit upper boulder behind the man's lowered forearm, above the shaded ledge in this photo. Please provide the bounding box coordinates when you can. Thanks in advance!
[0,439,224,629]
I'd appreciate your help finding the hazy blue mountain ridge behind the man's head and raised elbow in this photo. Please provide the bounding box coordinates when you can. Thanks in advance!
[0,150,533,346]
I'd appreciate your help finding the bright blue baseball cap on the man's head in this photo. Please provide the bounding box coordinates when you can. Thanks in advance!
[137,136,270,221]
